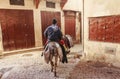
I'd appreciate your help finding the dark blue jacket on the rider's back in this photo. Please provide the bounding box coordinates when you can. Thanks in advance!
[44,24,62,42]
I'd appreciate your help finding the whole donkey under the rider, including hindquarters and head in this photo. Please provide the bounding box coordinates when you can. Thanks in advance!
[43,35,74,77]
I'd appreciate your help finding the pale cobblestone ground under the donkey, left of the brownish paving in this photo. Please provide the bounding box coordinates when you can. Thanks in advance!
[0,48,80,79]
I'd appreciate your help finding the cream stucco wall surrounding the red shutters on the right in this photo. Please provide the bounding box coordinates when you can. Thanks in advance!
[84,0,120,66]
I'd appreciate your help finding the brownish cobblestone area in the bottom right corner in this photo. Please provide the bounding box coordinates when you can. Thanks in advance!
[67,61,120,79]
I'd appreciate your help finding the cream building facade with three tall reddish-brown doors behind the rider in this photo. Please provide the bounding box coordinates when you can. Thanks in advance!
[0,0,80,55]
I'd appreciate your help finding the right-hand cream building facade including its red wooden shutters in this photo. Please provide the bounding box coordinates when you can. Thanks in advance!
[82,0,120,67]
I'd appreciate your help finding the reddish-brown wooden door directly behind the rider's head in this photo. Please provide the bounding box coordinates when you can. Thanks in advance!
[41,11,61,45]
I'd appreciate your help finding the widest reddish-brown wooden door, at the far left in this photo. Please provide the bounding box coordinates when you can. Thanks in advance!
[0,9,35,51]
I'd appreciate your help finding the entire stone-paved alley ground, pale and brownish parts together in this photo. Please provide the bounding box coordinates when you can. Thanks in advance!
[0,45,120,79]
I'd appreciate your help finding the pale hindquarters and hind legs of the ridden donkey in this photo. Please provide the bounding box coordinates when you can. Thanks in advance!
[43,42,63,77]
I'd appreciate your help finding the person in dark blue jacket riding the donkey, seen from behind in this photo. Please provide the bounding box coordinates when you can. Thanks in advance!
[44,19,68,63]
